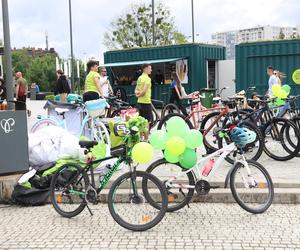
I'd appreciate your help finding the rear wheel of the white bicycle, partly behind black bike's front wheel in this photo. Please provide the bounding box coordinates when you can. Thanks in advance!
[143,159,195,212]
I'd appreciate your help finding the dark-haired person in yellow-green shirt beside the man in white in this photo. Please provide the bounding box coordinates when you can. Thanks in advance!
[83,60,104,102]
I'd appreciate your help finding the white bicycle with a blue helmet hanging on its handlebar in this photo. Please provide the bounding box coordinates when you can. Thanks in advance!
[146,127,274,214]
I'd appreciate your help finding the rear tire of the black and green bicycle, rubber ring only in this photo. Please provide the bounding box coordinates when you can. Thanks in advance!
[50,163,89,218]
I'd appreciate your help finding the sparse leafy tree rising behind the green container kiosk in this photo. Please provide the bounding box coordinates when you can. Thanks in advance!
[104,3,187,49]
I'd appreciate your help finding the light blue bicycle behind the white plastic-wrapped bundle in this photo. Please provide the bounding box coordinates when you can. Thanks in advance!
[30,99,111,148]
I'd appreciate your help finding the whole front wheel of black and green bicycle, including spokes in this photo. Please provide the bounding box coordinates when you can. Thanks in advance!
[108,171,168,231]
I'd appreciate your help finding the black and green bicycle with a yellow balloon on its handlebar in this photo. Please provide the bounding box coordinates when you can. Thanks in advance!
[50,125,168,231]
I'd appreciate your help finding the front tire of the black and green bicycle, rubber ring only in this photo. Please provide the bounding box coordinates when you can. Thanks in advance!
[108,171,168,231]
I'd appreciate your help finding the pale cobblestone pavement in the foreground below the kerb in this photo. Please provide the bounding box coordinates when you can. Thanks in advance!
[0,204,300,249]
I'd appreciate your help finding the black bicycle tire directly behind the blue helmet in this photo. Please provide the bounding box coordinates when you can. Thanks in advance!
[218,121,265,164]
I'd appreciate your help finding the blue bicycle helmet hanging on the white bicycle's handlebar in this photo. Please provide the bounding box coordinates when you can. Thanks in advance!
[230,127,256,147]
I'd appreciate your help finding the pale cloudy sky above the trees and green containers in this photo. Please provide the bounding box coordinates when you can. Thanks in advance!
[0,0,300,59]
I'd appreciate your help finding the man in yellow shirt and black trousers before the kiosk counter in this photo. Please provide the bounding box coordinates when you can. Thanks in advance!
[135,64,153,140]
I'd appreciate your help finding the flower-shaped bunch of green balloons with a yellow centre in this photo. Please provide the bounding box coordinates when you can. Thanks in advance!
[150,116,203,169]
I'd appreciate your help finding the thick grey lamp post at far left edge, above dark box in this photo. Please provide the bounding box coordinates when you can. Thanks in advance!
[2,0,14,109]
